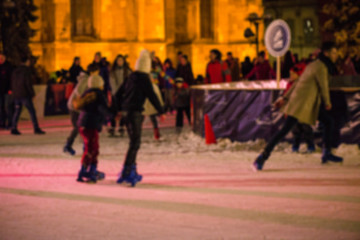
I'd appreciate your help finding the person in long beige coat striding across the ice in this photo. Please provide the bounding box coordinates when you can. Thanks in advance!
[253,42,343,171]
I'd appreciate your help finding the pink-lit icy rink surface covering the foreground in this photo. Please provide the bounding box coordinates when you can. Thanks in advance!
[0,116,360,240]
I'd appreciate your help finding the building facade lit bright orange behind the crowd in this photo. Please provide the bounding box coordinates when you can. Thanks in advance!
[31,0,264,78]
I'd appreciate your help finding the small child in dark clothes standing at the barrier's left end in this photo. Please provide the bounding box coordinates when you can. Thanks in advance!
[174,77,191,133]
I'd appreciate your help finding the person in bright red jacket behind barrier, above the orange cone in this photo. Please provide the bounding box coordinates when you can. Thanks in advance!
[205,49,231,83]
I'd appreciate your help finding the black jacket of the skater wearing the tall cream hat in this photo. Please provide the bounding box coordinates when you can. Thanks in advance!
[121,71,163,113]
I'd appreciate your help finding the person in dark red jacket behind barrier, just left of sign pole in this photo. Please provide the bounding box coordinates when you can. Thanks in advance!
[245,51,275,80]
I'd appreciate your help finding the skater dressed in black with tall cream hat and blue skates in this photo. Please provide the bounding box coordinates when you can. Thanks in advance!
[117,50,163,186]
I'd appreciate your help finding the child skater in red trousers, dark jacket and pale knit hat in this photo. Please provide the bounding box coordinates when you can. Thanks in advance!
[75,68,109,183]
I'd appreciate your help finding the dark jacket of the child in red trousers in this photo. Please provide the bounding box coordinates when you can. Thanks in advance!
[78,88,109,132]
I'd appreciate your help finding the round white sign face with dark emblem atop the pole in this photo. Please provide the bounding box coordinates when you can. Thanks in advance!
[265,19,291,57]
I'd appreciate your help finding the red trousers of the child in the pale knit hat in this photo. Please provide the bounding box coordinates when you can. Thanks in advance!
[79,128,99,167]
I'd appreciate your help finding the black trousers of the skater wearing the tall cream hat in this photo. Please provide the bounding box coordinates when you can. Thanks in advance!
[124,112,144,166]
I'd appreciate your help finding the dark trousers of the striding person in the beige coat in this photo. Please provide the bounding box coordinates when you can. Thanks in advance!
[264,106,334,155]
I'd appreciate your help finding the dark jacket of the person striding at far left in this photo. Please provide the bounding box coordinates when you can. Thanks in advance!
[11,65,35,99]
